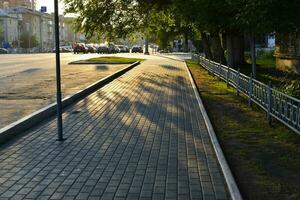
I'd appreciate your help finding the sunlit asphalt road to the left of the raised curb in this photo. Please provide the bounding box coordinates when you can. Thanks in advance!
[0,53,129,128]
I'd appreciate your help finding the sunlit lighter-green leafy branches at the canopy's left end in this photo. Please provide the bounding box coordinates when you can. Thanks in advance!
[64,0,170,38]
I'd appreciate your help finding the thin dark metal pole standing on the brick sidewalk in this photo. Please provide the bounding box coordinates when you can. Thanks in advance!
[54,0,64,141]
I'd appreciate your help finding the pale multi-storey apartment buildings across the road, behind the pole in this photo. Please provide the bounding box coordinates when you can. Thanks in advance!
[0,0,85,52]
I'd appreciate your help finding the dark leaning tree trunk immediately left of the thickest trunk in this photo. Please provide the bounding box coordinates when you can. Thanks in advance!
[211,32,226,64]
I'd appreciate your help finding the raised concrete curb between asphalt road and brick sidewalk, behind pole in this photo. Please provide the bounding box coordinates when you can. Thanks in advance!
[0,62,140,144]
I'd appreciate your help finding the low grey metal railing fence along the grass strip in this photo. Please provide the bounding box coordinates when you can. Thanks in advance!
[192,54,300,134]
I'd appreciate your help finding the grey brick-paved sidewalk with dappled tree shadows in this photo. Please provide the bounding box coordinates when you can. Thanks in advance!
[0,58,229,200]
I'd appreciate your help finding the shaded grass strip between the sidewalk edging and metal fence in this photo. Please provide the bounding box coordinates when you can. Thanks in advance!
[187,60,300,200]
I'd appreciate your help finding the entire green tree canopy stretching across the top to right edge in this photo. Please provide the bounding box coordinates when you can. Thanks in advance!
[64,0,300,45]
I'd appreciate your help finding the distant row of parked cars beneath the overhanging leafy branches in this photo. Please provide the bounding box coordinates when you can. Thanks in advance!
[73,43,143,54]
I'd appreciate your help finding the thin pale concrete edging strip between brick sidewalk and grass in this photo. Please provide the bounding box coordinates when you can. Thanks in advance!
[185,62,243,200]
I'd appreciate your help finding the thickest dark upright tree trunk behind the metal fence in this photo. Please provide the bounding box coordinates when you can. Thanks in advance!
[227,32,245,68]
